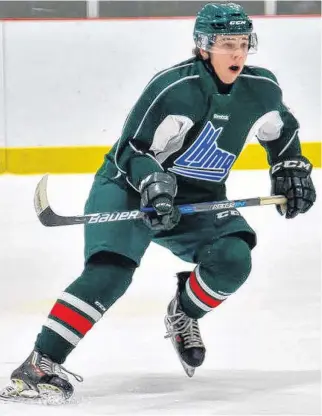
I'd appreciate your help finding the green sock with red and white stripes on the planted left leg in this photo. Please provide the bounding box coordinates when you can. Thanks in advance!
[35,252,136,364]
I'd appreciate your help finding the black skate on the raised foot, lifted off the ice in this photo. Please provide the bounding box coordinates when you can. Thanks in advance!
[164,272,206,377]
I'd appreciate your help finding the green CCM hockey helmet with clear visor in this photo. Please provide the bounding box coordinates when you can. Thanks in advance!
[193,3,257,53]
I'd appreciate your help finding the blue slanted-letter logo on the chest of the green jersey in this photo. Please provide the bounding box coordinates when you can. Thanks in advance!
[169,121,236,182]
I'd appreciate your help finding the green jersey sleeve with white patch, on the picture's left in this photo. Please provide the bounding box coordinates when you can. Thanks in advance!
[115,79,198,190]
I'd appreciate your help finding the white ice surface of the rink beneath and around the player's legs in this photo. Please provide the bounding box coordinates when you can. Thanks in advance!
[0,170,321,416]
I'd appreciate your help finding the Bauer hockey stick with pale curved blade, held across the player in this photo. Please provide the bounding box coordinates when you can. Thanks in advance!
[34,175,287,227]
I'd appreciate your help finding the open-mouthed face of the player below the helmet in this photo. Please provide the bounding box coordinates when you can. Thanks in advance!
[209,35,249,84]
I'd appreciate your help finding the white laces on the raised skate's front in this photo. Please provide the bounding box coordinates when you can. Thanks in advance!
[164,312,204,348]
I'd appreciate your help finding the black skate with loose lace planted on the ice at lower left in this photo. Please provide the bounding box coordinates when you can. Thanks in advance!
[0,351,83,405]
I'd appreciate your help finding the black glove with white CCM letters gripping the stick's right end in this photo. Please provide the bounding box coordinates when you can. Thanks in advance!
[270,156,316,218]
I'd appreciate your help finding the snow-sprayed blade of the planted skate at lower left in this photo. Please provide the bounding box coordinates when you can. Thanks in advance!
[0,380,68,406]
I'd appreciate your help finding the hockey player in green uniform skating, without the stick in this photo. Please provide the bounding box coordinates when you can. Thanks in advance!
[1,3,315,400]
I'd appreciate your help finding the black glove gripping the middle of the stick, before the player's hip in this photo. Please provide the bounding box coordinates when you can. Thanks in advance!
[140,172,180,231]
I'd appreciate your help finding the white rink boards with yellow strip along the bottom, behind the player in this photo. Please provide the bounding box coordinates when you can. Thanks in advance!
[0,16,321,174]
